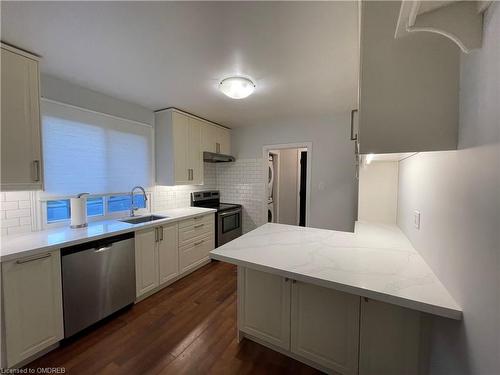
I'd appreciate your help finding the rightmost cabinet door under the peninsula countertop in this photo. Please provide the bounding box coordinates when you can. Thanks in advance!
[359,298,427,375]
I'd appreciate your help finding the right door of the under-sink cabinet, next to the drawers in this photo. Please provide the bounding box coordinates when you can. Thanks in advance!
[158,224,179,285]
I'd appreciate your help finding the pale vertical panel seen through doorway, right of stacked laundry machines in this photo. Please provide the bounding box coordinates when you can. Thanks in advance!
[278,148,298,225]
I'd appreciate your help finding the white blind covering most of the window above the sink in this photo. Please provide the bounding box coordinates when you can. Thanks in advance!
[41,100,153,196]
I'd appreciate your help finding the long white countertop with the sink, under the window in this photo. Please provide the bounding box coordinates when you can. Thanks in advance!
[0,207,216,262]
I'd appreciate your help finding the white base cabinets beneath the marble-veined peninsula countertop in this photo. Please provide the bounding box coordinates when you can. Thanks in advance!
[238,266,429,375]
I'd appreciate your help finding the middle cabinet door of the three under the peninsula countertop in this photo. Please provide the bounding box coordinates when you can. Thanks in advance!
[291,281,360,374]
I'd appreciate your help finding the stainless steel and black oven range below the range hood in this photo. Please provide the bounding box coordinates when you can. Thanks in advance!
[191,190,242,246]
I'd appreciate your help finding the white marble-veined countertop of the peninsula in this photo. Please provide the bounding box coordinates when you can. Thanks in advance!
[210,222,462,320]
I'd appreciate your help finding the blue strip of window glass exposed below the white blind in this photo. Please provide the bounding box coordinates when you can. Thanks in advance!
[47,194,147,224]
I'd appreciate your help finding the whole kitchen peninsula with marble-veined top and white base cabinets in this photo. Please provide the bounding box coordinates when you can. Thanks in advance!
[211,222,462,374]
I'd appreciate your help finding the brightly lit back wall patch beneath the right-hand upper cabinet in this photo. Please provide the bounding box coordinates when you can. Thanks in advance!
[358,161,398,224]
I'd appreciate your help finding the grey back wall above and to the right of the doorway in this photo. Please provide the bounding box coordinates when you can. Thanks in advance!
[231,113,357,231]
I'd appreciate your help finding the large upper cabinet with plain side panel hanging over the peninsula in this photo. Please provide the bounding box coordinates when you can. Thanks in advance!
[358,1,460,154]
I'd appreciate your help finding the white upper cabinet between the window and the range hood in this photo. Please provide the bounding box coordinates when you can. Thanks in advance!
[155,109,203,186]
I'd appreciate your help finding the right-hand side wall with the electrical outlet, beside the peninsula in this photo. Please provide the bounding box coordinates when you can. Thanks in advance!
[398,3,500,375]
